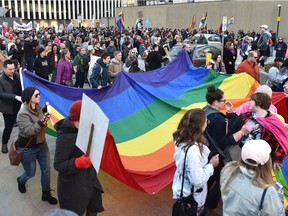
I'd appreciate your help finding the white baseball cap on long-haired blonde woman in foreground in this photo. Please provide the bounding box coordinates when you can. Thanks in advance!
[241,140,271,167]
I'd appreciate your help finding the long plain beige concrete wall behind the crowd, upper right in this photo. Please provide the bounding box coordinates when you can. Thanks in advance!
[117,0,288,35]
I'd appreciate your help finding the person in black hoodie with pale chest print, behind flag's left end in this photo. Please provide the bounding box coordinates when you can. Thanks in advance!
[33,47,51,80]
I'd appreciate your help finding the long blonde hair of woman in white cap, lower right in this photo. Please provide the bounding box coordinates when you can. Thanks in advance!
[222,157,275,193]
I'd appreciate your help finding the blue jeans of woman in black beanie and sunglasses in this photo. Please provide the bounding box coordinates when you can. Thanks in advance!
[17,141,50,191]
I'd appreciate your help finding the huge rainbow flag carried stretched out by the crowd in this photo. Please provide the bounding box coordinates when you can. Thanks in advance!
[22,52,286,194]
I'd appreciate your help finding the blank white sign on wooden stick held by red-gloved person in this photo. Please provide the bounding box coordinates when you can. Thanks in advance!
[76,94,109,172]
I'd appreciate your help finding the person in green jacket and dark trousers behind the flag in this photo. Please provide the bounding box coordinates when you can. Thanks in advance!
[72,46,89,88]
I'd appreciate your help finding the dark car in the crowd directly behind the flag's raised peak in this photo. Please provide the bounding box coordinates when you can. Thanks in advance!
[169,44,221,67]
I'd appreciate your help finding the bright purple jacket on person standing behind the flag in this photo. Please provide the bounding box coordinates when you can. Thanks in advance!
[56,59,73,84]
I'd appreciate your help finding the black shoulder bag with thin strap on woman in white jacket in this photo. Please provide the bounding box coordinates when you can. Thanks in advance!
[172,148,198,216]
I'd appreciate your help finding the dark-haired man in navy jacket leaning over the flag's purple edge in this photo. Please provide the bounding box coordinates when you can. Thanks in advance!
[90,52,110,89]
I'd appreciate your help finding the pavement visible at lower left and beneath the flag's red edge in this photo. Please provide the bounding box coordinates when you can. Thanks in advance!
[0,115,173,216]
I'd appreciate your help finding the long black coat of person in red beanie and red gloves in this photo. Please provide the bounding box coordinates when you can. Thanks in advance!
[54,117,104,215]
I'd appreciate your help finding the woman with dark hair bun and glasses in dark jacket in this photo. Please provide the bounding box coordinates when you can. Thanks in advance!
[203,86,250,209]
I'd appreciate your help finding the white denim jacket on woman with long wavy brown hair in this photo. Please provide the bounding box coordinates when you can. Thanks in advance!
[172,143,214,207]
